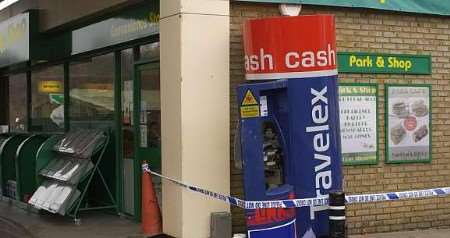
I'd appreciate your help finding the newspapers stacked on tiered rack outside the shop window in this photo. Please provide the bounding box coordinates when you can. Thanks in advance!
[28,130,105,215]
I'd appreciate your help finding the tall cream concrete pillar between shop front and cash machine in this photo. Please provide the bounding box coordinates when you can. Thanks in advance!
[160,0,230,238]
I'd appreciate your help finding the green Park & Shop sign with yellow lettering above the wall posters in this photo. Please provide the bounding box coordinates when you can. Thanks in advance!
[338,52,431,74]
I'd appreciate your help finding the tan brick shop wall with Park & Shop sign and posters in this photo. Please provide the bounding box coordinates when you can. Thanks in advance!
[230,0,450,234]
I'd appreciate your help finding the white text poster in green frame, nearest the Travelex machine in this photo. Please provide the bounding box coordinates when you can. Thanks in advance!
[339,84,378,165]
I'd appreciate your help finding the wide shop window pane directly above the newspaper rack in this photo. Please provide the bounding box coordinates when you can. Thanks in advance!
[69,53,114,128]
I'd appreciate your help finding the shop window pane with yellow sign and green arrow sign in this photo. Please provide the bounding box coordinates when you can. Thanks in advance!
[29,65,64,131]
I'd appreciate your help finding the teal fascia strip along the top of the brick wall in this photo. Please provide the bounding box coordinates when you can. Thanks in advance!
[236,0,450,16]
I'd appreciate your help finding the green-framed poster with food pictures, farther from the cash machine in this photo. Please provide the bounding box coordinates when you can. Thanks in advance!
[386,85,431,163]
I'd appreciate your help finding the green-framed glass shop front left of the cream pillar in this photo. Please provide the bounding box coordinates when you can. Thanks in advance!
[0,1,161,220]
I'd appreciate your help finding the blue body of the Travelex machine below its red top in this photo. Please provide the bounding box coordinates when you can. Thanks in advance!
[238,76,342,237]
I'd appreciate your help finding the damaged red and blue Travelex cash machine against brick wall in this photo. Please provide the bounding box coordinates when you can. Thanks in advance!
[238,15,342,238]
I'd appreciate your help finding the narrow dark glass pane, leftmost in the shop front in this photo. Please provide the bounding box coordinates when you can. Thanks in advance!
[9,73,27,132]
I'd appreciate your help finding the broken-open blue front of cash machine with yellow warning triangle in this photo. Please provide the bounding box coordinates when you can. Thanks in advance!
[238,80,296,238]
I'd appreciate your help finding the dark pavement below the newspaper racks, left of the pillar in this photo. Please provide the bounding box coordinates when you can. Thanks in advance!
[0,201,145,238]
